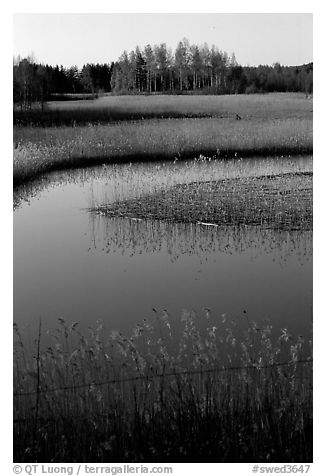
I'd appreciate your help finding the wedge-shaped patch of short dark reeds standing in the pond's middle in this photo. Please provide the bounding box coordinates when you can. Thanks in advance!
[93,172,312,230]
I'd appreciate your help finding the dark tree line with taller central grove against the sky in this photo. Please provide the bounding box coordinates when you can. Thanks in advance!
[13,38,313,108]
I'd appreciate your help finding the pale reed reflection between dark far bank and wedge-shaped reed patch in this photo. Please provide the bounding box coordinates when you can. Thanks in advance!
[15,156,312,208]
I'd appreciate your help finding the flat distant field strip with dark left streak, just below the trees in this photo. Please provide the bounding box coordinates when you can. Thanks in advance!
[14,93,312,126]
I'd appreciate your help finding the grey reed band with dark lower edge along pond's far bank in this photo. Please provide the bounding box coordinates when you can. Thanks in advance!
[13,117,312,185]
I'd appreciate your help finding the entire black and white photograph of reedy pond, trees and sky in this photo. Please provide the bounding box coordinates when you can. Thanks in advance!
[8,5,313,468]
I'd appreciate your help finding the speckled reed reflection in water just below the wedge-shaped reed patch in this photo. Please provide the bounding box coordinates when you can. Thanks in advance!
[90,214,312,263]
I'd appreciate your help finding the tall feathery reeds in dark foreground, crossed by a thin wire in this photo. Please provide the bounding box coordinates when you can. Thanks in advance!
[14,309,312,462]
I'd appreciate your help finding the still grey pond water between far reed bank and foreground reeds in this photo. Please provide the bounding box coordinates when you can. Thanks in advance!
[14,157,312,346]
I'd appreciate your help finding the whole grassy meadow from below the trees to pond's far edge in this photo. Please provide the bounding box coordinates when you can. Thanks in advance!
[13,94,313,185]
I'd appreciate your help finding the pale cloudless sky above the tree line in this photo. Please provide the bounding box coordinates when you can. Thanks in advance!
[13,13,313,67]
